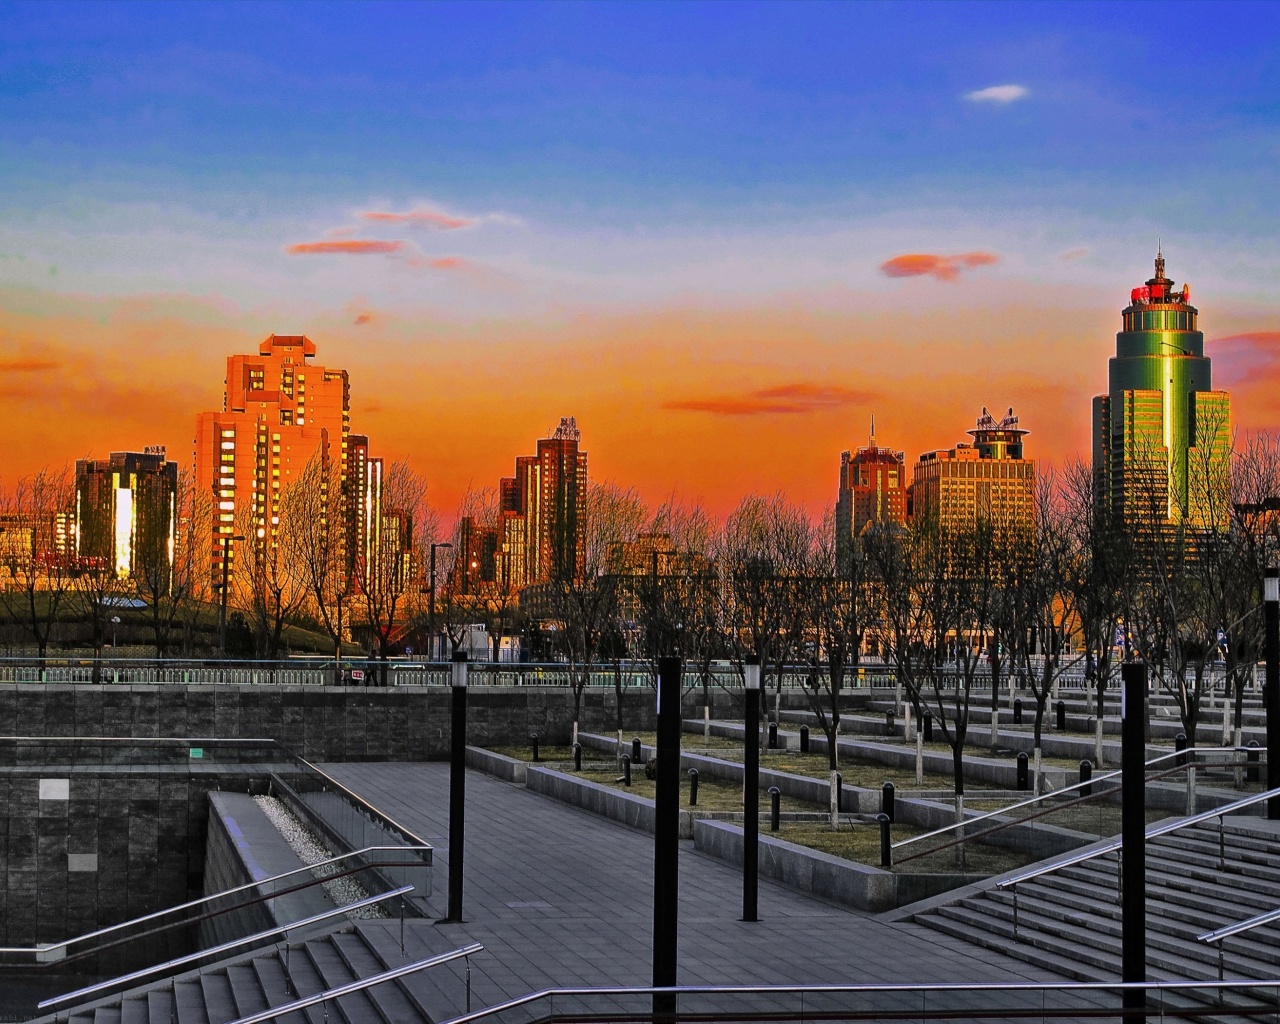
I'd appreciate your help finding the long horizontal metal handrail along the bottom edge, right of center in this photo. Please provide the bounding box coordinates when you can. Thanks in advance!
[437,979,1280,1024]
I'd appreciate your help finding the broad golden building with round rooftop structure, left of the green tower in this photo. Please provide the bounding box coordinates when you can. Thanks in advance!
[911,408,1036,532]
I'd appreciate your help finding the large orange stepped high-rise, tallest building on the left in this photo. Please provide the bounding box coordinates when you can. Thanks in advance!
[196,334,351,575]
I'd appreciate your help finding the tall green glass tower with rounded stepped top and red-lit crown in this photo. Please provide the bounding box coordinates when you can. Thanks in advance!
[1093,253,1231,532]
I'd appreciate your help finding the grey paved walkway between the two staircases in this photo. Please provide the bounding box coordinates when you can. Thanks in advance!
[324,763,1061,1019]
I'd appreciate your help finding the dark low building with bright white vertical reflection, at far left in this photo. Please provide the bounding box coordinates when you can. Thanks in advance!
[76,448,178,590]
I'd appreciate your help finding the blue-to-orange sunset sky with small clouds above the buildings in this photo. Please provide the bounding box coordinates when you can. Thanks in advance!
[0,4,1280,515]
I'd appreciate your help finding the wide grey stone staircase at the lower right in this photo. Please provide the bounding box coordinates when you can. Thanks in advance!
[911,817,1280,1003]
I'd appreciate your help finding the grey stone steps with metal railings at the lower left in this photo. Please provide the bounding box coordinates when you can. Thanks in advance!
[44,922,462,1024]
